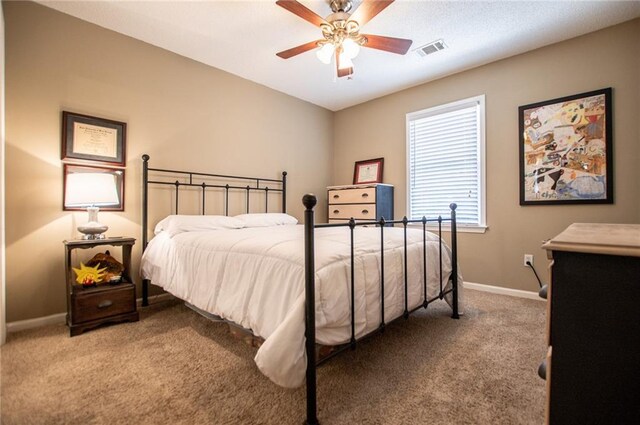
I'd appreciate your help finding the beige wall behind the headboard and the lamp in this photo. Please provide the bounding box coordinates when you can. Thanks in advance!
[4,2,333,322]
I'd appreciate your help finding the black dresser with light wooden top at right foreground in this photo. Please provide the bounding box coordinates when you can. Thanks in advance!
[542,223,640,425]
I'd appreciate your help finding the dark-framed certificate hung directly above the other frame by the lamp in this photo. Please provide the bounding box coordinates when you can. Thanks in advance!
[61,111,127,167]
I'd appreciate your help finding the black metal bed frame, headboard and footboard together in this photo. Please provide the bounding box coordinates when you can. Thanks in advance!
[142,154,459,425]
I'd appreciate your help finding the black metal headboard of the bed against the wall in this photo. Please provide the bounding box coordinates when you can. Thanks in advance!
[142,154,287,250]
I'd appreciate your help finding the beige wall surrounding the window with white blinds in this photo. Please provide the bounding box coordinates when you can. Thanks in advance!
[332,19,640,291]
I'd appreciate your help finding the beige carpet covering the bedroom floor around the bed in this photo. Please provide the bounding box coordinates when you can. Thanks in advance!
[0,290,545,425]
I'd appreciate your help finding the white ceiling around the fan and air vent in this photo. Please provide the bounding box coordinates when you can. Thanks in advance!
[40,0,640,111]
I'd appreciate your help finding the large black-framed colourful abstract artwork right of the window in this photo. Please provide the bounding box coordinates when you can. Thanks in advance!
[518,87,613,205]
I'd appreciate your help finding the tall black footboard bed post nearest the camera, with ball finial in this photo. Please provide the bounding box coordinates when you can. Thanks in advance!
[302,193,318,425]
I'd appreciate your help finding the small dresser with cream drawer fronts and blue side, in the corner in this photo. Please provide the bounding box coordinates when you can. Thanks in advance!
[327,183,393,223]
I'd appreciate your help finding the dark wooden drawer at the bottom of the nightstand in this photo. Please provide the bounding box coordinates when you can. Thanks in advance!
[71,283,136,323]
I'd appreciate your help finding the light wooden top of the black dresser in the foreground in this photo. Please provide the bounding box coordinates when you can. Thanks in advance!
[542,223,640,257]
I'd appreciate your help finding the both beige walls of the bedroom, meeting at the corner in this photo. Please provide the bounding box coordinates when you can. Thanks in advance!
[3,2,640,321]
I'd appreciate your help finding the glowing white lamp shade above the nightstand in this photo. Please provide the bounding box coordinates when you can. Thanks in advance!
[65,173,120,207]
